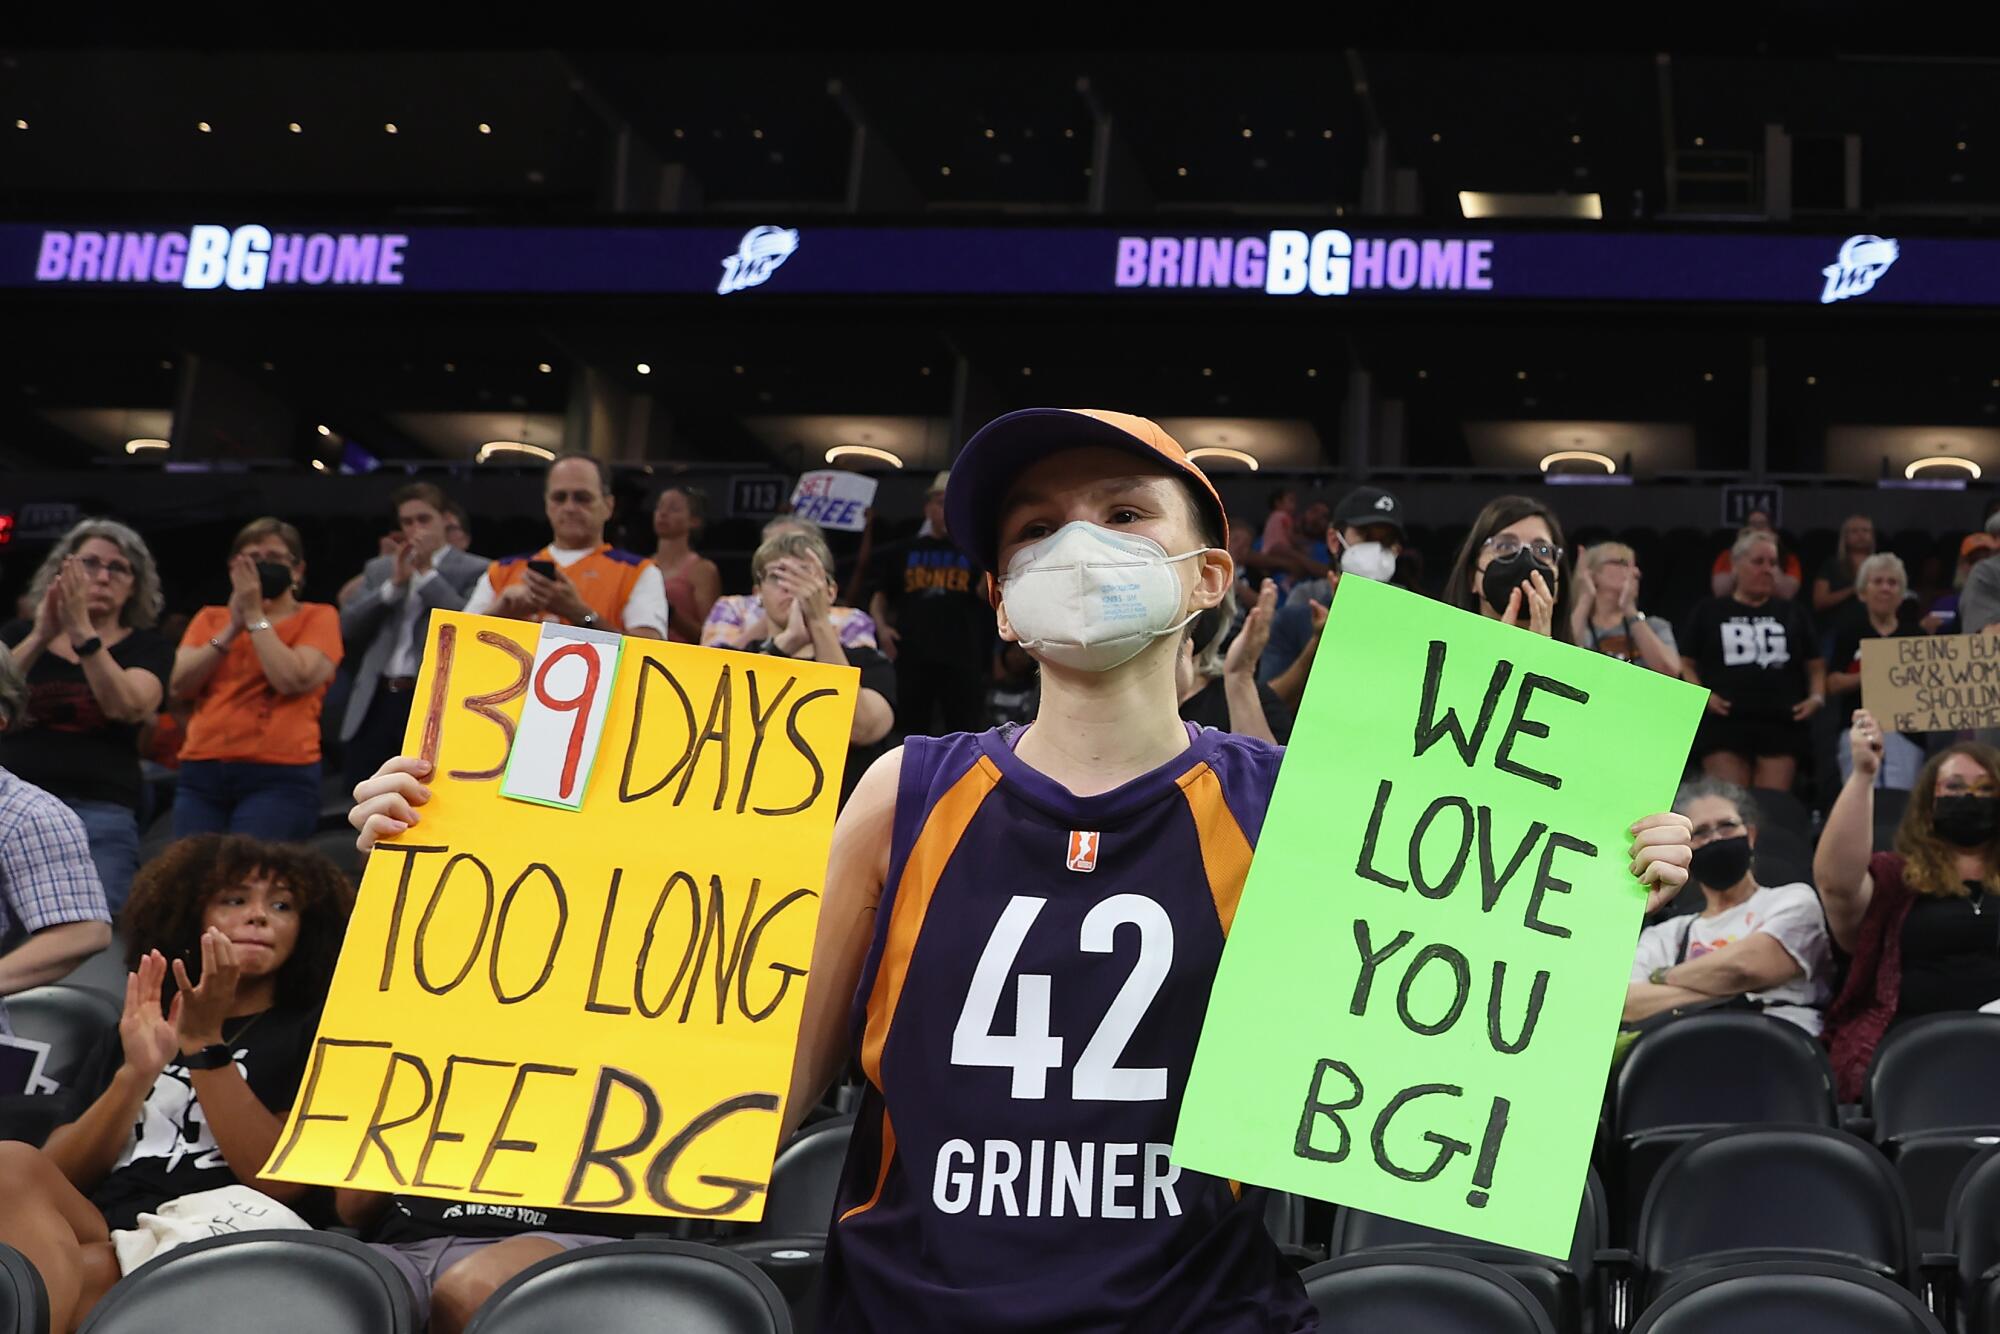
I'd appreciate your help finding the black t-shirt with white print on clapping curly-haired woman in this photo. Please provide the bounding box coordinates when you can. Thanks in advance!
[76,1010,320,1228]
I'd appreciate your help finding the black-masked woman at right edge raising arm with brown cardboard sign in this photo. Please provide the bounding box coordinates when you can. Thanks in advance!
[1812,724,2000,1102]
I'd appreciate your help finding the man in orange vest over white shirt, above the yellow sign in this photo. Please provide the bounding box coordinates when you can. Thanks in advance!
[466,454,666,640]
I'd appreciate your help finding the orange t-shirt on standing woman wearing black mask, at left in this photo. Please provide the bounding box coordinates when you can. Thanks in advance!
[180,602,340,764]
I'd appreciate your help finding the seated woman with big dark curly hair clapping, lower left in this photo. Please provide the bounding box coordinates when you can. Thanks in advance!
[0,834,354,1330]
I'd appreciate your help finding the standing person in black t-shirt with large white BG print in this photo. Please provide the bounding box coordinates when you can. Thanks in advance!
[1680,532,1826,792]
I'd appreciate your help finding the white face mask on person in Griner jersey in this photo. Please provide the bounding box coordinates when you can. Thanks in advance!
[1000,520,1208,672]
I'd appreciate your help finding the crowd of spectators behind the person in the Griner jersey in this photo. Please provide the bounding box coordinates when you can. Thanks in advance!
[0,456,2000,1330]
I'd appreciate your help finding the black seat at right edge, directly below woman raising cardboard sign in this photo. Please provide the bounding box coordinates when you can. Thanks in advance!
[1864,1014,2000,1250]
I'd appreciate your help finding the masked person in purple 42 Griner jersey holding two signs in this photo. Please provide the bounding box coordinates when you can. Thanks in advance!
[350,408,1688,1334]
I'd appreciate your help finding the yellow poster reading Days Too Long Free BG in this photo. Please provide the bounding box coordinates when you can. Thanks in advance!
[264,612,858,1220]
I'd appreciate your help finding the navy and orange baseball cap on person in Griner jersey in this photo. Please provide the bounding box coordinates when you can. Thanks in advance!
[944,408,1230,570]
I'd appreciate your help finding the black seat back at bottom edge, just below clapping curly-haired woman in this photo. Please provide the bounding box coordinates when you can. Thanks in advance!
[82,1230,416,1334]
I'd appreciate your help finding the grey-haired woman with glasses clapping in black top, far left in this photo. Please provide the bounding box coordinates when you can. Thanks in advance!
[0,518,174,914]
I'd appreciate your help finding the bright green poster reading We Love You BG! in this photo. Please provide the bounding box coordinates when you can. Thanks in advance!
[1174,578,1704,1256]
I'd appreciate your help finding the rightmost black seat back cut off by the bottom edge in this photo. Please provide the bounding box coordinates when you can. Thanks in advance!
[1632,1264,1944,1334]
